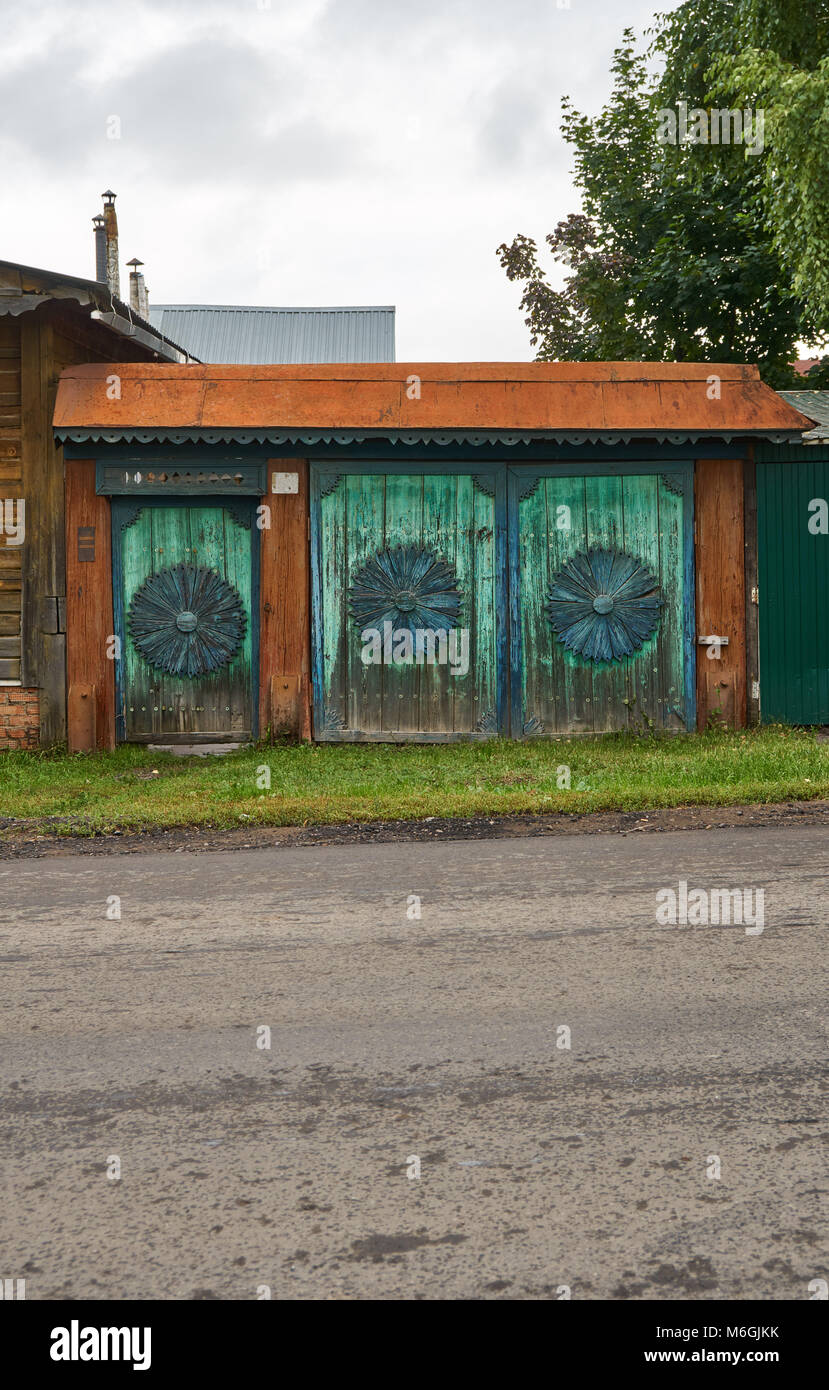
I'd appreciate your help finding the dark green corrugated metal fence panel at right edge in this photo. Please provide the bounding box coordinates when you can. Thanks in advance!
[757,445,829,724]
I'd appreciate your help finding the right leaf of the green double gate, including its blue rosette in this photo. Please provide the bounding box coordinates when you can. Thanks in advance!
[509,467,695,737]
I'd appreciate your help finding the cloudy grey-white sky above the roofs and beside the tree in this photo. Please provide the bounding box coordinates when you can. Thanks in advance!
[0,0,679,360]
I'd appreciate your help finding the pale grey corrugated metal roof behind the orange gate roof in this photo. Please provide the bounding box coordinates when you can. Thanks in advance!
[150,304,395,366]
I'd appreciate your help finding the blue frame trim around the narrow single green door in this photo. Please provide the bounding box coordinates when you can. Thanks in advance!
[110,493,261,744]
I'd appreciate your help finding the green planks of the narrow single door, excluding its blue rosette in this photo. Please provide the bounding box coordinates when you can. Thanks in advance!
[113,498,259,741]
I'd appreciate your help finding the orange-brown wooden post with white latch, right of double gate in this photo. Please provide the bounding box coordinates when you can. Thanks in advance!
[694,459,746,728]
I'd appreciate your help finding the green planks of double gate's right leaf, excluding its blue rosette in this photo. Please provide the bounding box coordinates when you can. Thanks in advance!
[509,466,695,737]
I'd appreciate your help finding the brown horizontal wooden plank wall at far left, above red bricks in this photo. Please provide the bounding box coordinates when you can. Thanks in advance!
[0,318,22,681]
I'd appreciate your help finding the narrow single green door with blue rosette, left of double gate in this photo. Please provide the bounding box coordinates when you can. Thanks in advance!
[113,498,257,742]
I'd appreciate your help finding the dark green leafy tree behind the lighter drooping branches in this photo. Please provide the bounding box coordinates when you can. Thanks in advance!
[498,0,819,386]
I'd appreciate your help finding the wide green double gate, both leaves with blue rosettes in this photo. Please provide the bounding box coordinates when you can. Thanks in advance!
[312,463,695,741]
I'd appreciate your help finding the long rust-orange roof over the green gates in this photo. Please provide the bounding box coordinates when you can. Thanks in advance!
[54,361,811,436]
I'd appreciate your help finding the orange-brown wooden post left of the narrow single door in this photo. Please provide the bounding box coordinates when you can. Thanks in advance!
[65,459,115,752]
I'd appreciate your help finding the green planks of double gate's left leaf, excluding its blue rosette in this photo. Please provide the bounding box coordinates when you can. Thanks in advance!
[312,467,497,741]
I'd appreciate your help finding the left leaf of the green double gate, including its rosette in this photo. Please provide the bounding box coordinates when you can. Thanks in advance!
[312,464,506,741]
